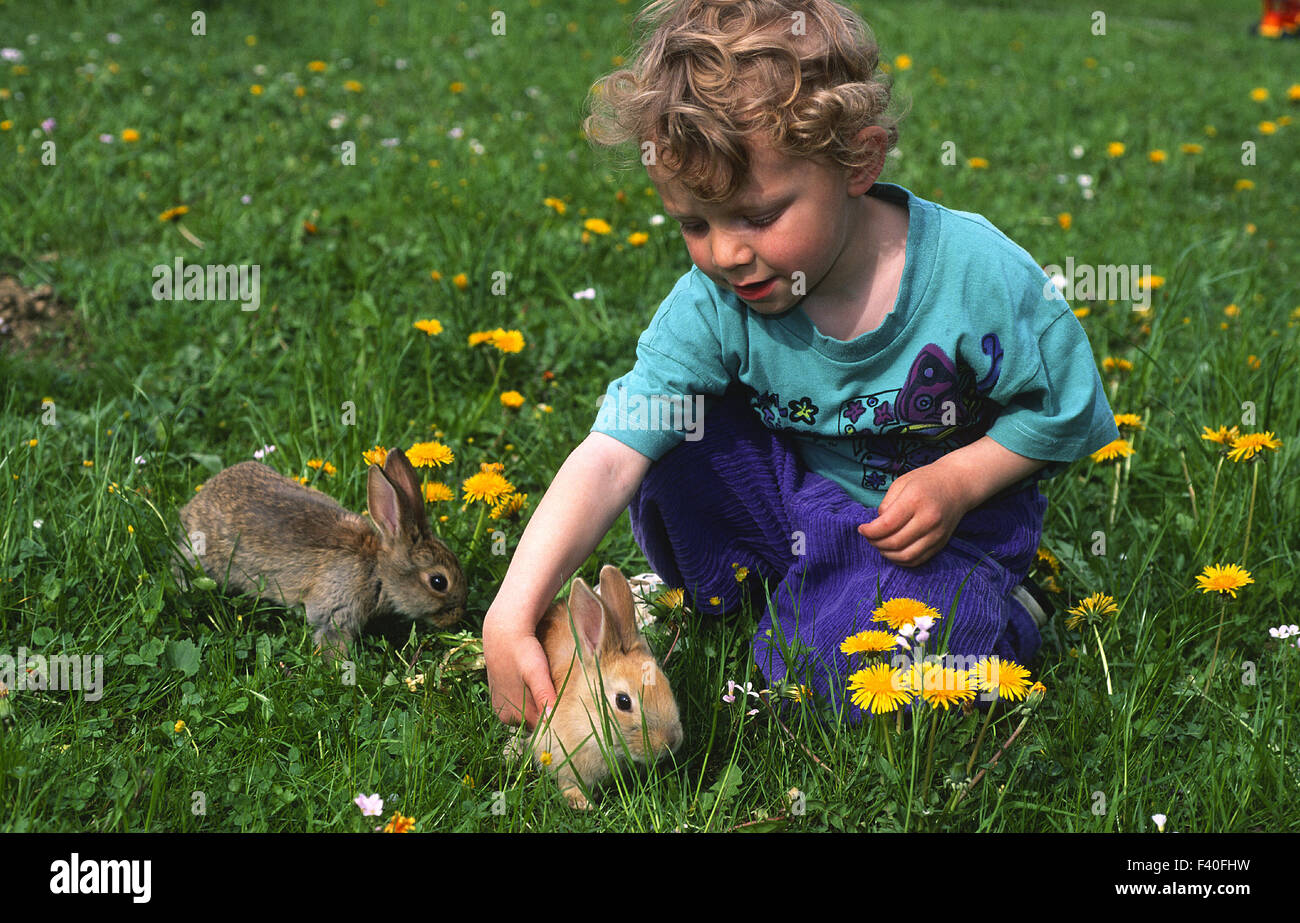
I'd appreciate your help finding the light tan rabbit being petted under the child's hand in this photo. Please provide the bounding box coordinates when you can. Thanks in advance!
[514,564,683,810]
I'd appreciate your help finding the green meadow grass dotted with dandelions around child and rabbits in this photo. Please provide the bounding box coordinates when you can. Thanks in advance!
[0,0,1300,832]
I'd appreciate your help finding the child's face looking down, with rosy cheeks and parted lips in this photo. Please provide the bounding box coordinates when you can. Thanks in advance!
[650,136,879,315]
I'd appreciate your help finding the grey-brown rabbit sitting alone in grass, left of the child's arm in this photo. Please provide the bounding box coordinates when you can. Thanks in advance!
[181,449,465,653]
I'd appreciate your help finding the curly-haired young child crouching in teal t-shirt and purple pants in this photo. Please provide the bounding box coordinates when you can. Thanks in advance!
[484,0,1118,725]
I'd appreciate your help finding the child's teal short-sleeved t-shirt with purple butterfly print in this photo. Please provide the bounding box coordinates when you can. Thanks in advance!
[592,183,1119,507]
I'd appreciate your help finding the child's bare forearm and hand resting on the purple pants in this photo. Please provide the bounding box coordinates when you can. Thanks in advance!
[858,436,1047,567]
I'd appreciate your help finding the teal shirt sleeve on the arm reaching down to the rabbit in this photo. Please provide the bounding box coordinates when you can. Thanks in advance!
[590,270,735,462]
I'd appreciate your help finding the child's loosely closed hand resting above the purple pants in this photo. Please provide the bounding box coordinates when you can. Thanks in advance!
[858,464,972,567]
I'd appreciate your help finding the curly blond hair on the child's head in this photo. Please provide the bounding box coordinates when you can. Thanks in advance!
[582,0,898,202]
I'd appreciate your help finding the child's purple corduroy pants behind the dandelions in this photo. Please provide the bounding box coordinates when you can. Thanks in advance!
[629,387,1047,720]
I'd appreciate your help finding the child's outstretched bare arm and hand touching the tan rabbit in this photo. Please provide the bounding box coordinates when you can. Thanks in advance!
[484,433,650,727]
